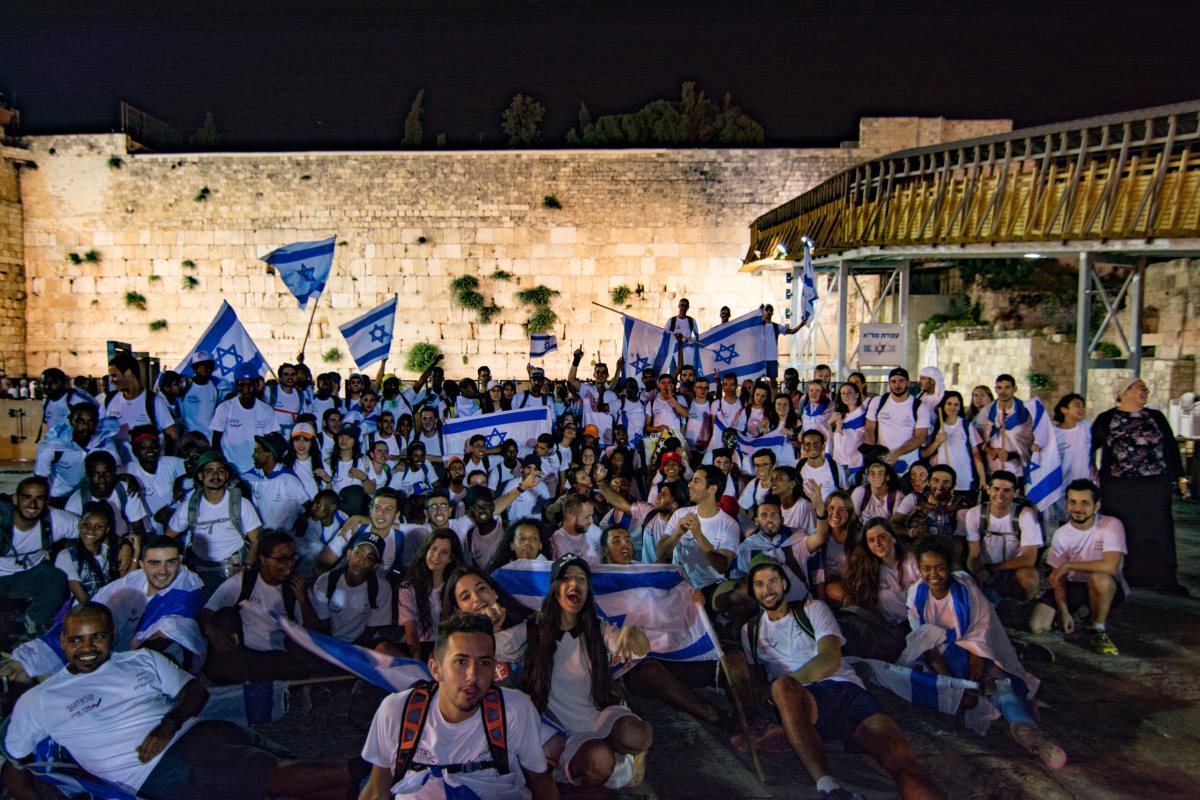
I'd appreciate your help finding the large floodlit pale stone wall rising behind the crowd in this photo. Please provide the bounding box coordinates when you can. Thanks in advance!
[22,136,856,374]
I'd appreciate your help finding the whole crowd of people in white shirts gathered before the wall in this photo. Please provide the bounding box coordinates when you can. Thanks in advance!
[0,305,1186,799]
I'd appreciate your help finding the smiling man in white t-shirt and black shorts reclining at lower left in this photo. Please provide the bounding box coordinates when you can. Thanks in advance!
[4,602,352,800]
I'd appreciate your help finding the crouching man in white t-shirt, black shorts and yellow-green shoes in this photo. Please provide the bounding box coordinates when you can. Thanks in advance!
[1030,479,1129,656]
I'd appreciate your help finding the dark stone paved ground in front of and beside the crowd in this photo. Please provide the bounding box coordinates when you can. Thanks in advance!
[0,476,1200,800]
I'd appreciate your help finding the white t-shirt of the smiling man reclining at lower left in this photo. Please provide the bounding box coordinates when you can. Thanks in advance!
[5,649,197,794]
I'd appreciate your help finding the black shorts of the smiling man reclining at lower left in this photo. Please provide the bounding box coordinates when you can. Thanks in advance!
[138,720,278,800]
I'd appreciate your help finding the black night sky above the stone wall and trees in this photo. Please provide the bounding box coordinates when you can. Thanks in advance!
[0,0,1200,149]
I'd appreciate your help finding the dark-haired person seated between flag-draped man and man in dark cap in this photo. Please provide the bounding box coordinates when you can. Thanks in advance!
[199,533,338,684]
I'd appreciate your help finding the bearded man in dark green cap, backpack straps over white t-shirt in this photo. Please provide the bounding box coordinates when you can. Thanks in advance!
[167,450,263,595]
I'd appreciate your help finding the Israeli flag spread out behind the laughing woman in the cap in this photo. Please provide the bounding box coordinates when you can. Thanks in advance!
[492,561,721,661]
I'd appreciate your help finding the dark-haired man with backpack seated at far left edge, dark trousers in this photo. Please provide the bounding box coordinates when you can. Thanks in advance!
[0,475,79,648]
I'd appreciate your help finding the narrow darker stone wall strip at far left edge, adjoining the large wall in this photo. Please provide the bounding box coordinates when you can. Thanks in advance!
[0,146,25,375]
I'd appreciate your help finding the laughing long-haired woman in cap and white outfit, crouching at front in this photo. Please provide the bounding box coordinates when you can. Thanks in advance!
[524,554,654,789]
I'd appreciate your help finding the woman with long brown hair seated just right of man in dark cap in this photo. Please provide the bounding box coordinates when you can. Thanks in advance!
[396,528,464,658]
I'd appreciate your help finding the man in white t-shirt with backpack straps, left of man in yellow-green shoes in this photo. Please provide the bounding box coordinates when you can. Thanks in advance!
[962,469,1044,602]
